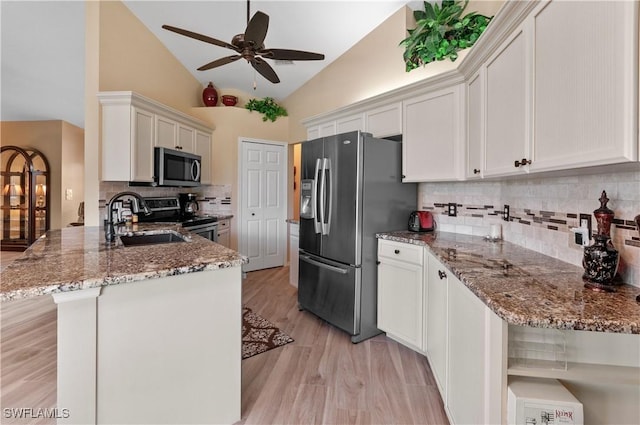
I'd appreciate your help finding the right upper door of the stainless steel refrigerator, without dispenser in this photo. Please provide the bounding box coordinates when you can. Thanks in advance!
[320,131,362,266]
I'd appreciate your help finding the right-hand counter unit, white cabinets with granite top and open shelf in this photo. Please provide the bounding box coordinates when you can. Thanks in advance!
[377,231,640,423]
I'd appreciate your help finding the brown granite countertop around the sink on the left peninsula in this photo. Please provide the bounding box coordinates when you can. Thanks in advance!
[0,223,248,302]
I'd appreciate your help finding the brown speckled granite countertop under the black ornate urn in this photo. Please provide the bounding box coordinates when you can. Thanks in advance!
[376,231,640,334]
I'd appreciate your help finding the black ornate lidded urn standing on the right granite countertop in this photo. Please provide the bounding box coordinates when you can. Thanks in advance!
[582,190,619,292]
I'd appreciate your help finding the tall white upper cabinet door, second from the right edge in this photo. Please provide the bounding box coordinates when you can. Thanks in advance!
[483,28,530,176]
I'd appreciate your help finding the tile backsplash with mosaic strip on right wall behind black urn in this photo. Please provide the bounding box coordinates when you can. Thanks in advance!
[418,171,640,287]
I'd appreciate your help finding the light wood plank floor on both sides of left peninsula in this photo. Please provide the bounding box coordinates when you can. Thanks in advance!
[0,267,448,425]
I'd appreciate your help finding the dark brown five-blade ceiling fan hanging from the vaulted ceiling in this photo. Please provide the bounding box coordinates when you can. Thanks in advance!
[162,0,324,84]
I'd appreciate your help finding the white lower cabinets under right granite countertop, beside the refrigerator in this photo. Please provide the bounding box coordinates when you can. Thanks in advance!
[378,240,507,424]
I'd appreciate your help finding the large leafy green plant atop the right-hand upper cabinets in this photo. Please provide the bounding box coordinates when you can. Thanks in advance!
[400,0,493,72]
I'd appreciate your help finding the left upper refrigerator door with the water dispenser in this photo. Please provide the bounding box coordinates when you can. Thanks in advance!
[300,139,324,255]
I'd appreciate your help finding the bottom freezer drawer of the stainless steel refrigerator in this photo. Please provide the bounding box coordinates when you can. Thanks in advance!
[298,251,360,335]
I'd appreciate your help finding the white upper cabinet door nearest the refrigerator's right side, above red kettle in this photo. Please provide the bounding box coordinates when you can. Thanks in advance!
[402,85,464,182]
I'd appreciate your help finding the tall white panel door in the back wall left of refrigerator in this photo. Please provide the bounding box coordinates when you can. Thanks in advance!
[240,141,287,271]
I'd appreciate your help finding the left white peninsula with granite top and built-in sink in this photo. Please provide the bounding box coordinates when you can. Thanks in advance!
[0,224,247,424]
